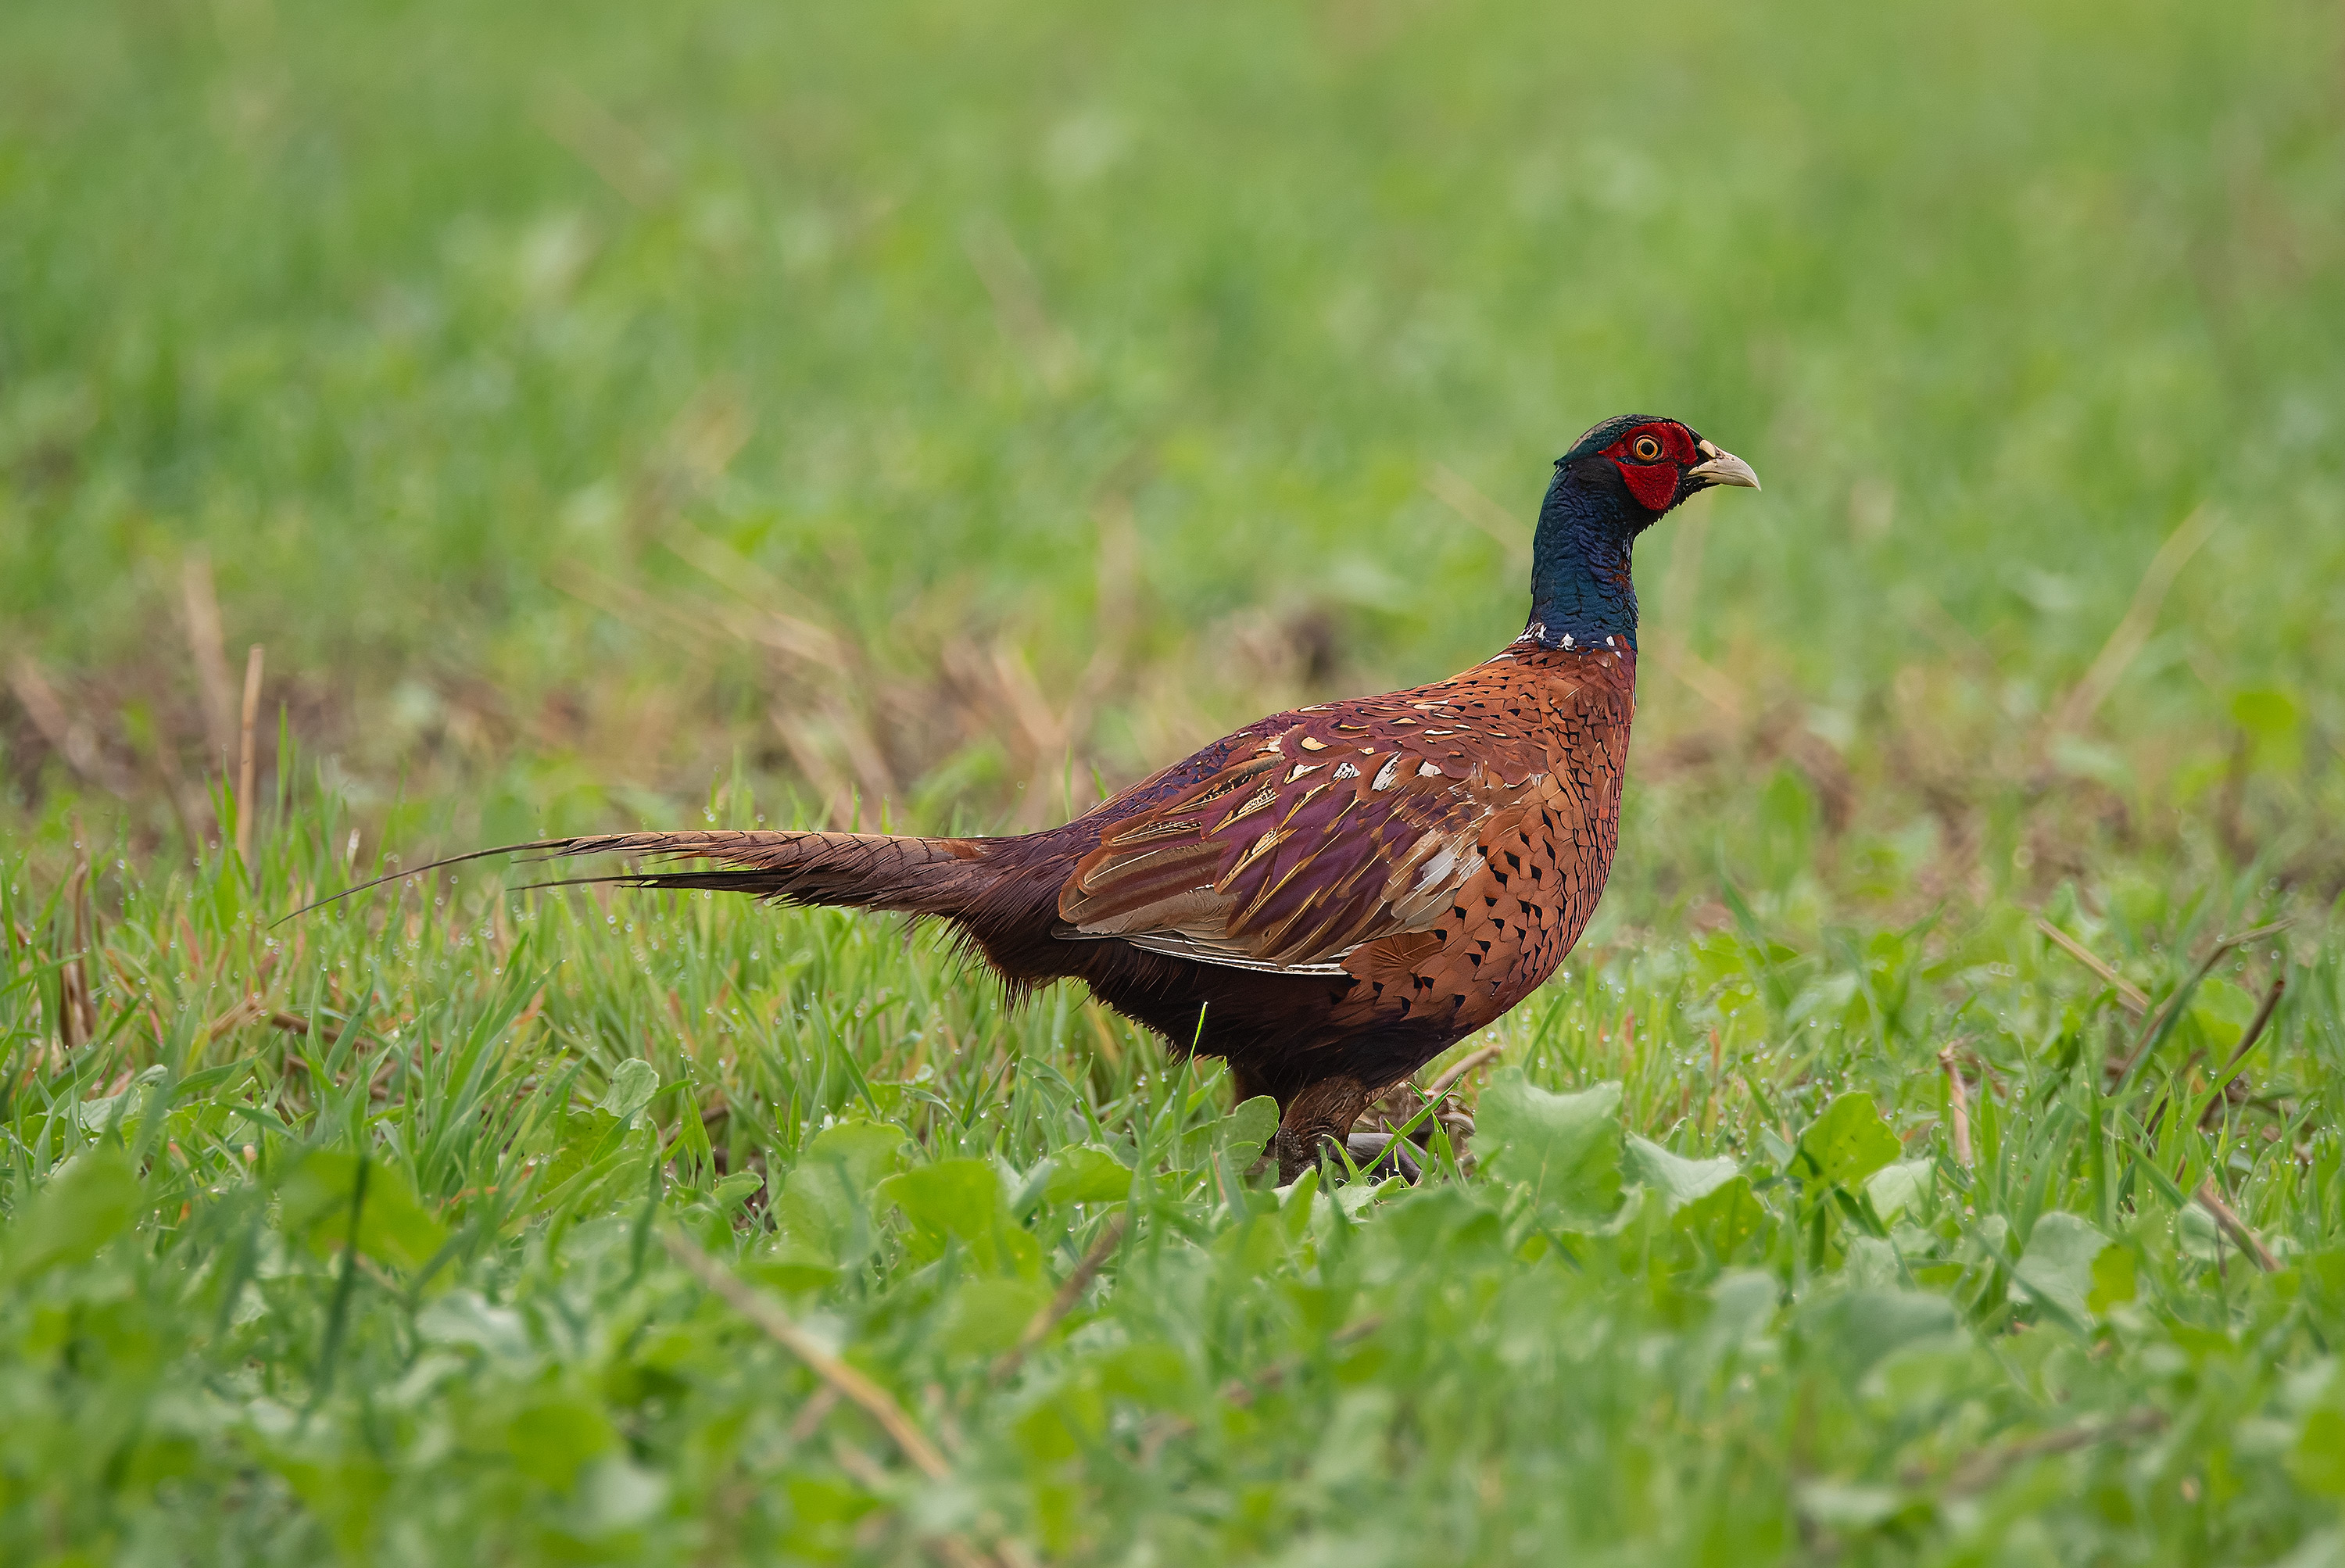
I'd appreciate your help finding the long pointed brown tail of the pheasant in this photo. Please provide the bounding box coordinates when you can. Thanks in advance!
[286,829,992,918]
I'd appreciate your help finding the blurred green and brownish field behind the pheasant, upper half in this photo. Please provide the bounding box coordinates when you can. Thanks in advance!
[0,0,2345,881]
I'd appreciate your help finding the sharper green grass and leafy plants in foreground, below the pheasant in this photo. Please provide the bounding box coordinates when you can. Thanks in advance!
[0,778,2345,1561]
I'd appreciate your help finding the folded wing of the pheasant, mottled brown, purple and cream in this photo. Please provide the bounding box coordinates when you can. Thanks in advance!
[1058,687,1550,972]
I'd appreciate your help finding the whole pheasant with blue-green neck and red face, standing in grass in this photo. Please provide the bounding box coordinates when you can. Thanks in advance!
[352,415,1759,1181]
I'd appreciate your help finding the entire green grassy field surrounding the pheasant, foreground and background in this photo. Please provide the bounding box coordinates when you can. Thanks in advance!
[0,0,2345,1568]
